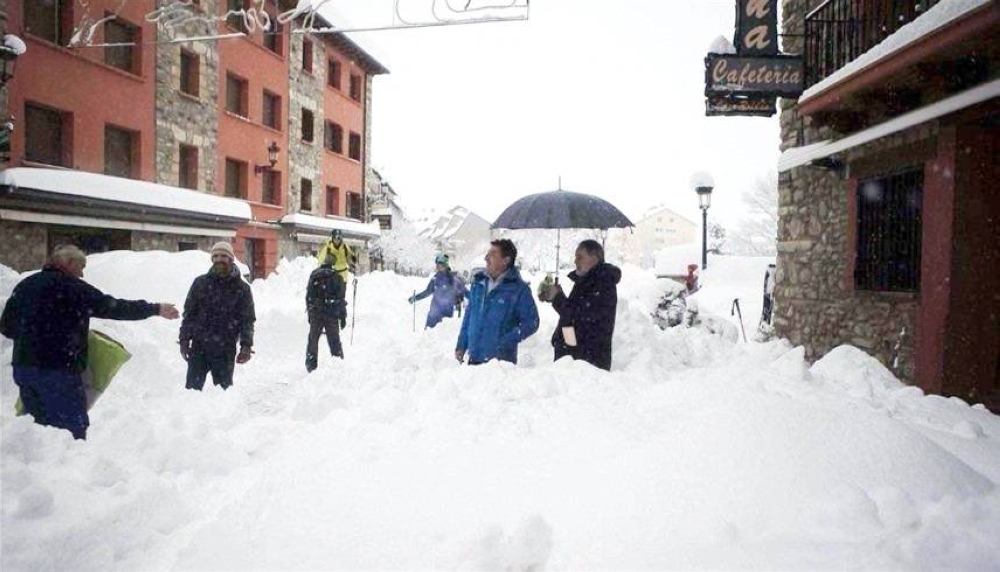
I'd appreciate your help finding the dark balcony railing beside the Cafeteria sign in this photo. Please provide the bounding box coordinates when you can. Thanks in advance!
[804,0,941,87]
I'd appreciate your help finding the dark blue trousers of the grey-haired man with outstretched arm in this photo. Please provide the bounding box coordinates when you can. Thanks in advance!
[14,366,90,439]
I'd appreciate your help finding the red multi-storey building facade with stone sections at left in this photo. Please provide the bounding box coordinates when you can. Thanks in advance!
[0,0,386,277]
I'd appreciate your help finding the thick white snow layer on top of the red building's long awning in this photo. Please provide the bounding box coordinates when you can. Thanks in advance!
[0,167,252,221]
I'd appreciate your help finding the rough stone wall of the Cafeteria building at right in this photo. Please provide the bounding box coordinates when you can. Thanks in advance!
[774,0,934,381]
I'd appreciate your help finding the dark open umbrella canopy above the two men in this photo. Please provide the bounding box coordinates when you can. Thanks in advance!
[493,191,635,230]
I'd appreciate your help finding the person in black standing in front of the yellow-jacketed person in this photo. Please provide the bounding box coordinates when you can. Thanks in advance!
[306,255,347,371]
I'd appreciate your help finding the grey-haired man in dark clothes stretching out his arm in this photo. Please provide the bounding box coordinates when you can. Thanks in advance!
[0,245,178,439]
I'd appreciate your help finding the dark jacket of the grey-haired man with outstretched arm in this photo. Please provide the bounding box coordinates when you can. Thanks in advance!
[0,266,160,373]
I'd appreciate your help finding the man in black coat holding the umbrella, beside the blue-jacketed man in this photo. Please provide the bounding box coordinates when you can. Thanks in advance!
[542,240,622,371]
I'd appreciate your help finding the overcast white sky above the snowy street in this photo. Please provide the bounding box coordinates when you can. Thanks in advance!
[330,0,779,228]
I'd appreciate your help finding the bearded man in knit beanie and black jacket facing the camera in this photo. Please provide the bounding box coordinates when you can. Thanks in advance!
[179,242,257,391]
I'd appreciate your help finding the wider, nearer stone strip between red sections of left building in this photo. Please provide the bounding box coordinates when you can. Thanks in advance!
[156,0,221,193]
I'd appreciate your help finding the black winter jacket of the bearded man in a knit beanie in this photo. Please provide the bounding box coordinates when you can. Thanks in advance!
[180,267,257,350]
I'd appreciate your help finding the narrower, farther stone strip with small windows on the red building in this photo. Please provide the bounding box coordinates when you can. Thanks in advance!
[288,28,327,213]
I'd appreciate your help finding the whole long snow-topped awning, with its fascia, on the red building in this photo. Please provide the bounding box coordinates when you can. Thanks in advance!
[0,167,253,227]
